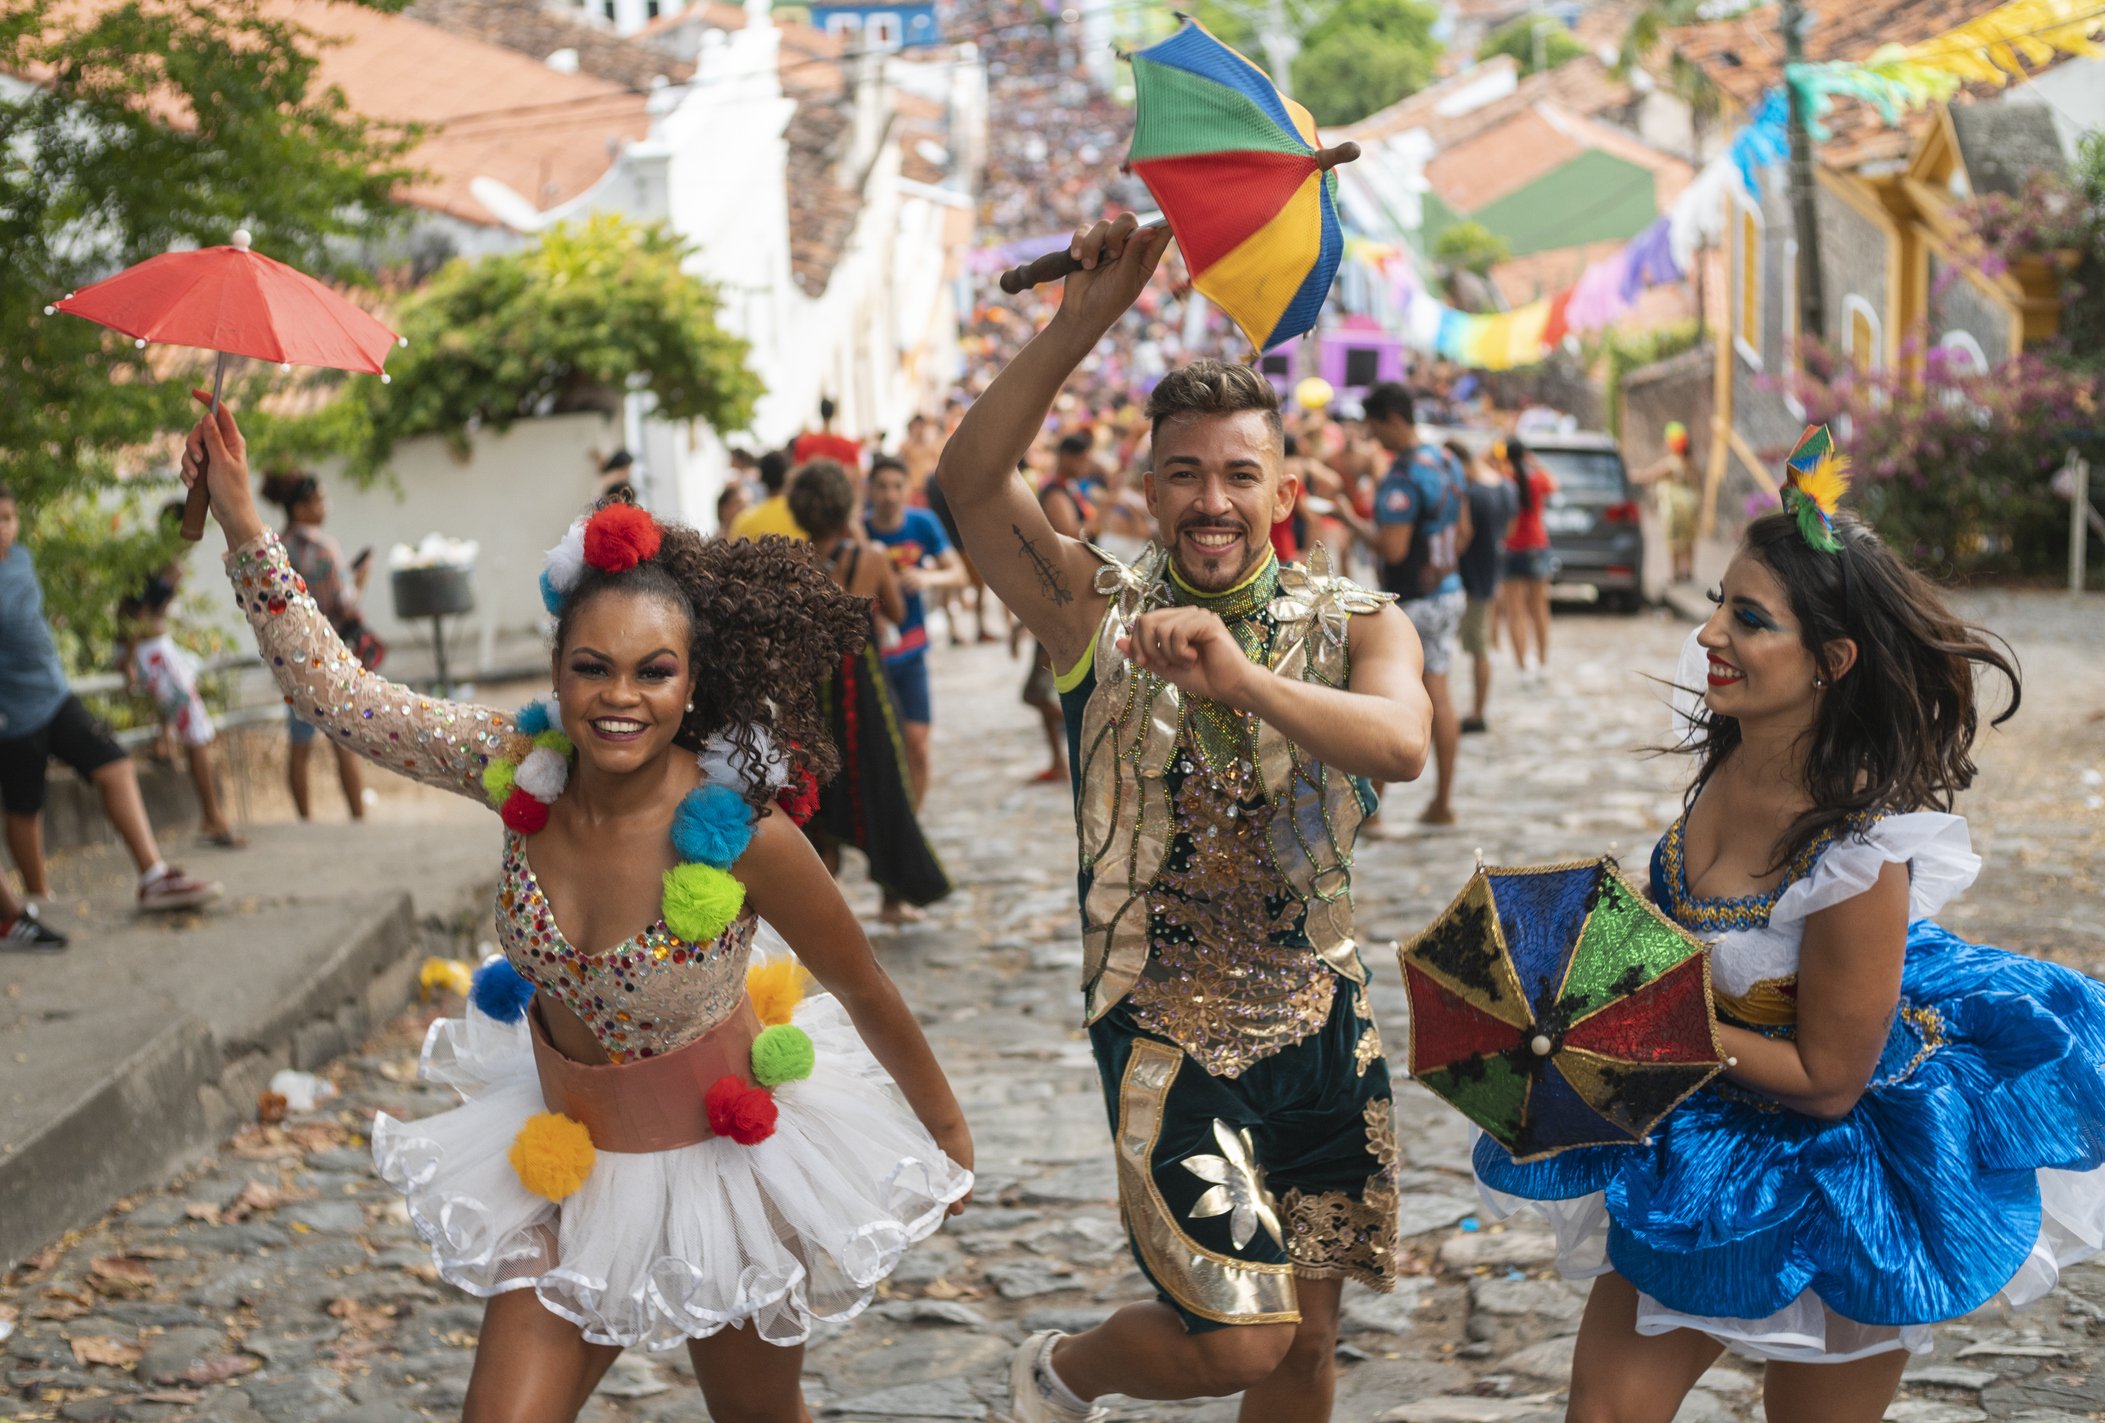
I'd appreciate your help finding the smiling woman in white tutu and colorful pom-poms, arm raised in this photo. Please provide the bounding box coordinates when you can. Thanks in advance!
[183,397,973,1423]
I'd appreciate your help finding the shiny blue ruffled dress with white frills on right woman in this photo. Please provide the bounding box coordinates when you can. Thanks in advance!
[1476,813,2105,1362]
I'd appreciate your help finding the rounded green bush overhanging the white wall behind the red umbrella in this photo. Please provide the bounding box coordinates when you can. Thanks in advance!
[341,215,762,474]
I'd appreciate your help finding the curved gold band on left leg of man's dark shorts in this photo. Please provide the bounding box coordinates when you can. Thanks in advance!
[1118,1038,1296,1324]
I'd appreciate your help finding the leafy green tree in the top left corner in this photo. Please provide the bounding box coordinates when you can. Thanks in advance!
[0,0,413,669]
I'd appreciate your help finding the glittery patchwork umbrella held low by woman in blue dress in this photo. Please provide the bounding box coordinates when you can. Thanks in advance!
[1400,859,1724,1162]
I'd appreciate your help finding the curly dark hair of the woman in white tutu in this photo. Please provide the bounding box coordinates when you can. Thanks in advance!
[556,501,869,810]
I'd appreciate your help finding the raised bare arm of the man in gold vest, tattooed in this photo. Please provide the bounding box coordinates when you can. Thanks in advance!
[937,213,1170,667]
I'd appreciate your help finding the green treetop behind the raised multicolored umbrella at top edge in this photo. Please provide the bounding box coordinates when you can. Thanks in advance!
[1194,0,1440,128]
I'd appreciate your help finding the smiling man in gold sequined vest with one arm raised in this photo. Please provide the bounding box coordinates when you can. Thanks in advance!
[937,215,1431,1423]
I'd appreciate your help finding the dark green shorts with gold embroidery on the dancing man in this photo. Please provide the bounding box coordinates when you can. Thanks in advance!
[1088,983,1398,1332]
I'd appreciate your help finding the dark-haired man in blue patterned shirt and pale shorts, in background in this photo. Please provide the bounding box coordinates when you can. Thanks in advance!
[1360,381,1474,825]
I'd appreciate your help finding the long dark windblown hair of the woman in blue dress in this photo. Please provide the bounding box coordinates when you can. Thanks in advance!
[1678,514,2023,869]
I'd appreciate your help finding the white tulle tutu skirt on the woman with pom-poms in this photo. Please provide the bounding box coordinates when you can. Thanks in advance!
[373,996,973,1349]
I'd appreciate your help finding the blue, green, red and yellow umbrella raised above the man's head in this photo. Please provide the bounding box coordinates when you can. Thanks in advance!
[1128,21,1360,352]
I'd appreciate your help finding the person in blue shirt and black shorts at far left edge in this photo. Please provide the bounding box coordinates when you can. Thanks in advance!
[0,486,219,909]
